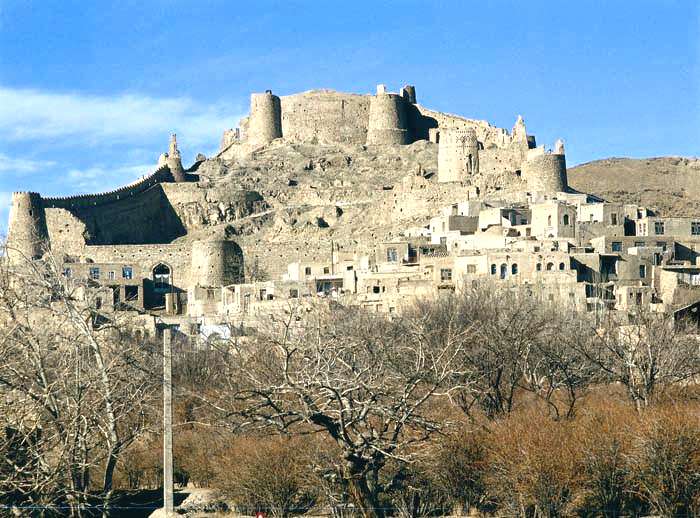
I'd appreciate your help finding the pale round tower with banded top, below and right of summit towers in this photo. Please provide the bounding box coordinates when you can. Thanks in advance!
[438,128,479,182]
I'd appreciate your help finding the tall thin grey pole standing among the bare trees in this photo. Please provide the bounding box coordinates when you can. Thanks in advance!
[163,328,174,517]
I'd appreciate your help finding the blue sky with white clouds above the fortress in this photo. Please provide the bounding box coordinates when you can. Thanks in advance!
[0,0,700,222]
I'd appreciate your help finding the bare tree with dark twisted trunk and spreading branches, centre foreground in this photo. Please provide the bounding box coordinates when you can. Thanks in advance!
[194,303,471,516]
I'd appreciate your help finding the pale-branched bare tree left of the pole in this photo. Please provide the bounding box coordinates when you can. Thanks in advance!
[0,249,158,513]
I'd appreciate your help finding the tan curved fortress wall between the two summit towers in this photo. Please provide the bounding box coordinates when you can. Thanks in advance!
[281,91,371,144]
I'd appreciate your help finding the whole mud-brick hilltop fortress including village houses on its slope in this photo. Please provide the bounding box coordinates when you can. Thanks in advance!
[7,85,700,338]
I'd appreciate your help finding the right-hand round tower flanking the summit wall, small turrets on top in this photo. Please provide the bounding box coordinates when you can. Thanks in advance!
[367,85,410,145]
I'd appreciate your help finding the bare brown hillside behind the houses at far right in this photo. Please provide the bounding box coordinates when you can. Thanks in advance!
[568,157,700,216]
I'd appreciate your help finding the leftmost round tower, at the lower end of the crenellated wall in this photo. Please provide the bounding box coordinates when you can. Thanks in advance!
[7,192,49,264]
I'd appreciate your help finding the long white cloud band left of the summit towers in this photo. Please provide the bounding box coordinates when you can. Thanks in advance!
[0,87,243,146]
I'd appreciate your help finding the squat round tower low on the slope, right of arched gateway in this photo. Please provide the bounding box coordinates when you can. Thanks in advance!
[192,240,243,286]
